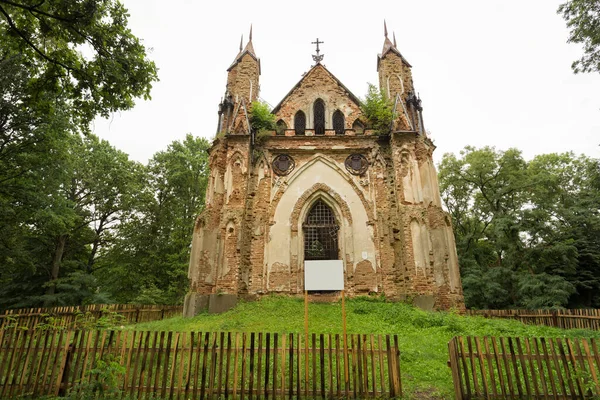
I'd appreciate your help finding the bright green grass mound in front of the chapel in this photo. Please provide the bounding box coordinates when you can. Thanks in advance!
[126,296,600,399]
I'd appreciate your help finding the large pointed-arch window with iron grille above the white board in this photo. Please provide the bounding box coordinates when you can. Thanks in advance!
[302,199,339,260]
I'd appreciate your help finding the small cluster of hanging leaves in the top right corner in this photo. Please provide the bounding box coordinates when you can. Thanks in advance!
[558,0,600,73]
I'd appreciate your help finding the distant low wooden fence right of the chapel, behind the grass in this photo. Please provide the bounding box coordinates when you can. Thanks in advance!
[467,309,600,330]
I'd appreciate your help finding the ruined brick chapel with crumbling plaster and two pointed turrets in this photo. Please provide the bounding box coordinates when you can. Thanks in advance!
[184,29,464,316]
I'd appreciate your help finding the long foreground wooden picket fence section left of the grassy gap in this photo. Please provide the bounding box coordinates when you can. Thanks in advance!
[0,329,402,399]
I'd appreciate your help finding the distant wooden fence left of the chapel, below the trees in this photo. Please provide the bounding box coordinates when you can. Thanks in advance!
[0,304,183,329]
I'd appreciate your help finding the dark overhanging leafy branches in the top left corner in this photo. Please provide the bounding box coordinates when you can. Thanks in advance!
[0,0,157,129]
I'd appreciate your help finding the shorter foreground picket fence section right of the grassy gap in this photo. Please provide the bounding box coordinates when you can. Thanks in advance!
[448,337,600,400]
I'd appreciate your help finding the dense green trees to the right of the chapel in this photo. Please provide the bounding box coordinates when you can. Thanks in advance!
[439,147,600,308]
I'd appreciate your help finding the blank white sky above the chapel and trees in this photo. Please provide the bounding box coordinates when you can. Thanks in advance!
[93,0,600,163]
